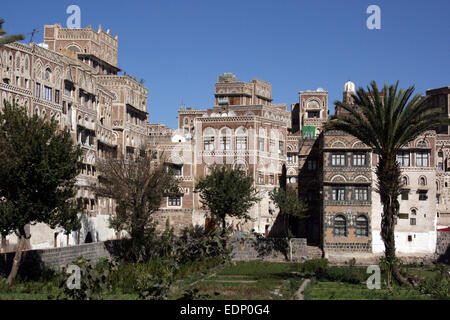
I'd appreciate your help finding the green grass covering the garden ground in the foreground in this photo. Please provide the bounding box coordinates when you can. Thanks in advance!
[0,259,450,300]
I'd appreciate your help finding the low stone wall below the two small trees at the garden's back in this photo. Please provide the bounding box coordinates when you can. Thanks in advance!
[230,236,307,262]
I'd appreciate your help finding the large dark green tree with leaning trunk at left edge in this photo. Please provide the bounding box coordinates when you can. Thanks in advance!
[0,101,82,284]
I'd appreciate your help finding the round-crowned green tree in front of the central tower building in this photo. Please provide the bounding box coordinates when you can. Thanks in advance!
[195,165,261,233]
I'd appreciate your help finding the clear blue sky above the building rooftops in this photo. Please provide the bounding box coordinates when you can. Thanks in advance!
[0,0,450,127]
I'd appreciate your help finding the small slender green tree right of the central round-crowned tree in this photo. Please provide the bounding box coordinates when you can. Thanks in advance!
[269,186,307,239]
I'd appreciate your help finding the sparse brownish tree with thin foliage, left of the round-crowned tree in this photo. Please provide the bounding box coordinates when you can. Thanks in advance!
[94,151,179,261]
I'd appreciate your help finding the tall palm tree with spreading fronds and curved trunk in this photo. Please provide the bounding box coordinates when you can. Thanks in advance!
[325,81,450,283]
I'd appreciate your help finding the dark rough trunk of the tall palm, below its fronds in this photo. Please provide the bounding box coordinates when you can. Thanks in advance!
[377,154,408,284]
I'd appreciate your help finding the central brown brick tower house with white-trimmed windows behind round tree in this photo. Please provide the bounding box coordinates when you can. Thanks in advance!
[153,73,290,233]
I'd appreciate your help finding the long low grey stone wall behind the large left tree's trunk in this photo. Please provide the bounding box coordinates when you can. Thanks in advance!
[0,240,120,276]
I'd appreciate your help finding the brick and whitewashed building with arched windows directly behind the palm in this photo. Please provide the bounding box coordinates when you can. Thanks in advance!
[322,82,442,255]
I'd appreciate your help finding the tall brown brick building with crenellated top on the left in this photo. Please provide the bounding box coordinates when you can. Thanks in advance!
[0,25,149,250]
